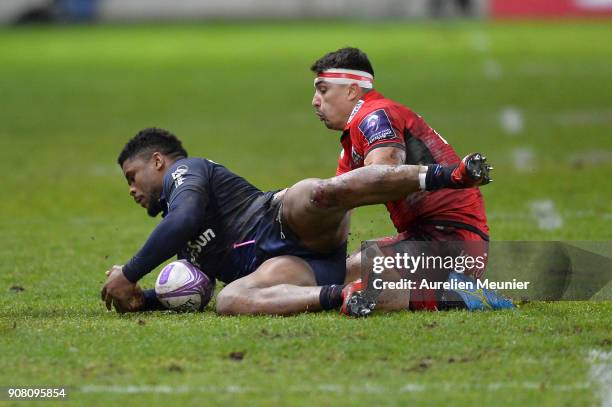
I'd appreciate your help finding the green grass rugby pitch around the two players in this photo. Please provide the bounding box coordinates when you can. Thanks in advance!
[0,23,612,406]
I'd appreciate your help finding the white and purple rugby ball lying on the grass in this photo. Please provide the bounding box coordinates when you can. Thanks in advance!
[155,260,215,312]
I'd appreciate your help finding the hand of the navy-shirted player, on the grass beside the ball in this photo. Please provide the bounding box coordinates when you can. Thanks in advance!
[100,265,144,313]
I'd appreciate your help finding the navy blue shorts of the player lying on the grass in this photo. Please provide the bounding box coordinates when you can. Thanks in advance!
[230,191,346,285]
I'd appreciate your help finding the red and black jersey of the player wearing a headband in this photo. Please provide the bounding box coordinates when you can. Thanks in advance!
[336,90,489,235]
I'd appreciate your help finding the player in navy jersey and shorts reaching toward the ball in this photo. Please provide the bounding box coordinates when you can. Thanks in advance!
[101,128,489,315]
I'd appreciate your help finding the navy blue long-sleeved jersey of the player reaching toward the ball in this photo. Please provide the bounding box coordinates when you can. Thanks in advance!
[123,158,267,282]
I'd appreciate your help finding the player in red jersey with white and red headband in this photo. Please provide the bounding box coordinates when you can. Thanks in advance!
[311,48,500,316]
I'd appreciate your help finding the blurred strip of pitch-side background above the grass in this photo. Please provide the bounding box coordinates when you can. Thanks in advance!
[0,0,612,23]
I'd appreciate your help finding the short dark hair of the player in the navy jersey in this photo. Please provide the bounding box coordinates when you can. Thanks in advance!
[117,128,187,166]
